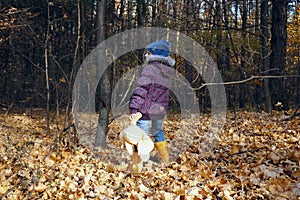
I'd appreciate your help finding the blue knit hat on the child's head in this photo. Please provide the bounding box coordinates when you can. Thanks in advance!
[146,40,171,57]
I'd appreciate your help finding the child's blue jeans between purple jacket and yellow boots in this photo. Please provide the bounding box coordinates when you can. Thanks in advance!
[137,120,165,142]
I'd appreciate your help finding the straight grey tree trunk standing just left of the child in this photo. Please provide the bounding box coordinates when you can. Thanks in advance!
[95,0,111,147]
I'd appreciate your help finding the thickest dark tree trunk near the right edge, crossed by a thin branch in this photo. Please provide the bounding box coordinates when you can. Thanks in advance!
[270,0,288,109]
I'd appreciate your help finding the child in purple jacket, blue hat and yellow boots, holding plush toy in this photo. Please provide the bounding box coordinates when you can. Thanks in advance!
[129,40,175,162]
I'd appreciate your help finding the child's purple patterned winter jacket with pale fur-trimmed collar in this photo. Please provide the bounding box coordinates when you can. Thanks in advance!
[129,55,175,120]
